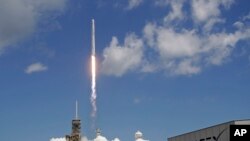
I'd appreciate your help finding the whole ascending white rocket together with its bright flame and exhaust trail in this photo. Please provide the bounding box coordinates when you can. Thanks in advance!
[90,19,97,118]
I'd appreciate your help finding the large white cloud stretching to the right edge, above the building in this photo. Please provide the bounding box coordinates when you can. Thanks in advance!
[144,23,250,75]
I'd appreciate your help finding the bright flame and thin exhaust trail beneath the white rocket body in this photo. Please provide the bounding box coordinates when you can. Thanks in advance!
[90,55,97,118]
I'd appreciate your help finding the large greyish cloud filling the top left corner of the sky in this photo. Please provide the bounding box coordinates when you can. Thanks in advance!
[0,0,66,54]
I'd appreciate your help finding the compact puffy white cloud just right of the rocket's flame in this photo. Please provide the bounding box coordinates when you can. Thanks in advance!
[102,34,143,76]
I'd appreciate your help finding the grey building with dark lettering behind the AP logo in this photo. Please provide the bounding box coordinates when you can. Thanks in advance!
[168,120,250,141]
